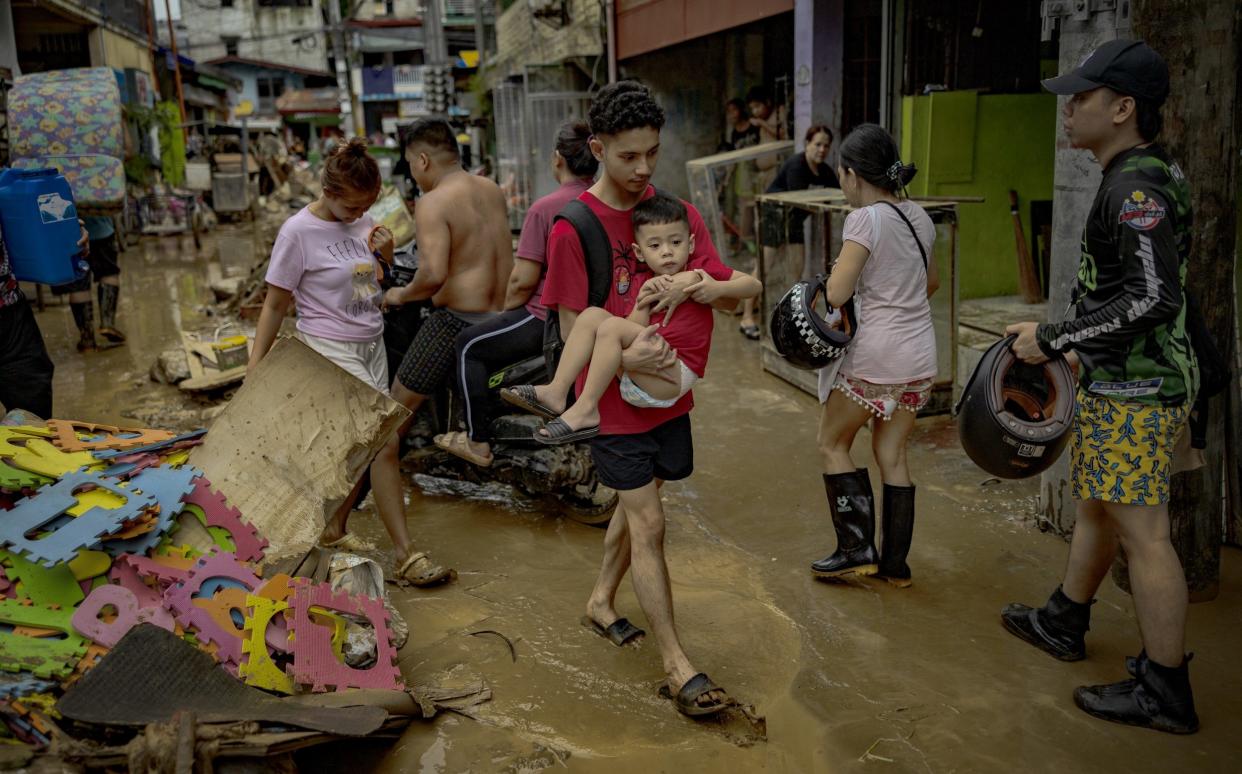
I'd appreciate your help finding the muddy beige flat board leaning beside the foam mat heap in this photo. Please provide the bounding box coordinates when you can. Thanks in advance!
[189,339,410,562]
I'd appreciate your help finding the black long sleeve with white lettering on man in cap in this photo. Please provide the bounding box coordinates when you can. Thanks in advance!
[1033,186,1182,357]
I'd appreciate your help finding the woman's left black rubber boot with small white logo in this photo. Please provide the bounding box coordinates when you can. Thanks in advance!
[811,471,879,579]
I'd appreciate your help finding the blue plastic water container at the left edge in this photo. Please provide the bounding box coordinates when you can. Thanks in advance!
[0,169,87,285]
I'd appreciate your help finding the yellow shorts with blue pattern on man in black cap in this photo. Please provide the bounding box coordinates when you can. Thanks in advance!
[1069,390,1186,506]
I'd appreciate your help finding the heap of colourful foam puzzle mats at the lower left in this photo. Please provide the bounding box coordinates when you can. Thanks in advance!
[0,420,405,747]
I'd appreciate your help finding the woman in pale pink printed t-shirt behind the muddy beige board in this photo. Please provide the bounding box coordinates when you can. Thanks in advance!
[250,138,450,585]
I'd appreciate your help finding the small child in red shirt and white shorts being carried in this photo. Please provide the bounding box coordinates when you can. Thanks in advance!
[502,193,763,444]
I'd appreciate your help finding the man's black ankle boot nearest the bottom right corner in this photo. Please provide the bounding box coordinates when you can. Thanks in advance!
[1074,651,1199,734]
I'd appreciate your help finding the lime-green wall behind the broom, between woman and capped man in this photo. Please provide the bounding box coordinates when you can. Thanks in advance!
[902,92,1057,299]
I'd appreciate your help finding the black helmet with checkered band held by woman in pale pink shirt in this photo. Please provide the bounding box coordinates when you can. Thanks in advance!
[769,275,857,370]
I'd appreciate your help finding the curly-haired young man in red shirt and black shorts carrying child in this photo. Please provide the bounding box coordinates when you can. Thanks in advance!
[509,81,760,717]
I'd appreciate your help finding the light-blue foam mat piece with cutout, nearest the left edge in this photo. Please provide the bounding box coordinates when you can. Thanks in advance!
[0,472,155,567]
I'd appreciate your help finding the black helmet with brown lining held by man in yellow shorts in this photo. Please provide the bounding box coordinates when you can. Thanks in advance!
[958,335,1074,478]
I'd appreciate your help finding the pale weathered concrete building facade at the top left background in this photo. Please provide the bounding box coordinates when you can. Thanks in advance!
[178,0,328,72]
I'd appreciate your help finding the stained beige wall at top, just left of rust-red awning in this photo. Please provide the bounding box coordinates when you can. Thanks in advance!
[488,0,598,84]
